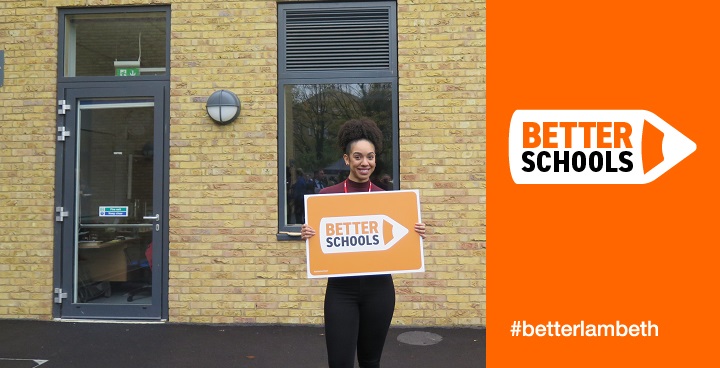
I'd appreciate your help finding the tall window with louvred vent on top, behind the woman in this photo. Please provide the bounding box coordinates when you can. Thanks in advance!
[278,1,399,238]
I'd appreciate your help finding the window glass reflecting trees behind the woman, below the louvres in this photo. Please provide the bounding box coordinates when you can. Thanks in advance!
[284,83,395,225]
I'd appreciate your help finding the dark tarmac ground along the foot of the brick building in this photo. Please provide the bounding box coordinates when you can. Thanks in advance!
[0,319,485,368]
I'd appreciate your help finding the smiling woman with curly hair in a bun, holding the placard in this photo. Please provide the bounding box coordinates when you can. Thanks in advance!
[300,118,425,368]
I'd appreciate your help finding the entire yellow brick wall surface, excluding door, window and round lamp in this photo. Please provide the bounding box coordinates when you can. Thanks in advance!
[0,0,485,326]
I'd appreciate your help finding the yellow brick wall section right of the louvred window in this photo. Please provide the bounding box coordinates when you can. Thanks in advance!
[394,0,485,326]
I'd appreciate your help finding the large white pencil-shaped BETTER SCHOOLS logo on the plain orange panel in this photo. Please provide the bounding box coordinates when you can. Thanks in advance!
[509,110,697,184]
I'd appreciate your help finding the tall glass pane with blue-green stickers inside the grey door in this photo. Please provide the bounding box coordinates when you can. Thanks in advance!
[74,98,155,304]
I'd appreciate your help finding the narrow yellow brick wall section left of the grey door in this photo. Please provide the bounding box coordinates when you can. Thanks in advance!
[0,1,57,319]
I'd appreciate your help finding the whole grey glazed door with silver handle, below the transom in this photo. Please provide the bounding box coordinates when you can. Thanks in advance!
[55,83,167,319]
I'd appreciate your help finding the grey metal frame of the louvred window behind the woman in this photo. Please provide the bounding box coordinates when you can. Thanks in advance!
[277,1,400,240]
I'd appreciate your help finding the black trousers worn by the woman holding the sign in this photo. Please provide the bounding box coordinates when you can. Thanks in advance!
[325,275,395,368]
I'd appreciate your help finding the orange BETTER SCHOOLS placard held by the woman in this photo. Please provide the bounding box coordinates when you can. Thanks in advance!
[305,190,425,278]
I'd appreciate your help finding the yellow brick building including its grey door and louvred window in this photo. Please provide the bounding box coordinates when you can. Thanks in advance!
[0,0,485,326]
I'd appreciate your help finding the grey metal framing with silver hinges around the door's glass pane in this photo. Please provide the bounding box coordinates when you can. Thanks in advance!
[53,81,169,320]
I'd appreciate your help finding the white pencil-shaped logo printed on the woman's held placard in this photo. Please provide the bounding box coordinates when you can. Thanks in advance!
[319,215,409,254]
